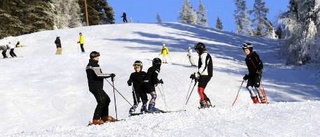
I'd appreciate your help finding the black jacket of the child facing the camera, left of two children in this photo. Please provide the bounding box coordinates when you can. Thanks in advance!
[128,71,147,93]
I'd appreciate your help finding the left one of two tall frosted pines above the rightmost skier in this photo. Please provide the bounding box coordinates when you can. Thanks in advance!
[234,0,253,35]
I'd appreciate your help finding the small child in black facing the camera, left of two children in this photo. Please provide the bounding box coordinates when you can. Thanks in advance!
[127,60,148,113]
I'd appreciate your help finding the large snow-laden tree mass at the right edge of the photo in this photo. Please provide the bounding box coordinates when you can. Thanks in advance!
[280,0,320,64]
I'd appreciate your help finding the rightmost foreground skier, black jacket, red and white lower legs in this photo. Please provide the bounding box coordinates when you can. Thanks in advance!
[242,43,267,104]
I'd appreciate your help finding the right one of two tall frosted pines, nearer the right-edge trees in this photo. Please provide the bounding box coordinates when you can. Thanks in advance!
[250,0,273,36]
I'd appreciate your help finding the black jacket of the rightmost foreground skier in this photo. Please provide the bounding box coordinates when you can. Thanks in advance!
[245,51,263,77]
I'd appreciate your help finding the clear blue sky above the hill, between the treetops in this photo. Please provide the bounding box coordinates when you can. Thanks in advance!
[108,0,289,31]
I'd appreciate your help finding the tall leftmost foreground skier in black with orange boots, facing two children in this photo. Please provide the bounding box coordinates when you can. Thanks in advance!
[86,51,116,125]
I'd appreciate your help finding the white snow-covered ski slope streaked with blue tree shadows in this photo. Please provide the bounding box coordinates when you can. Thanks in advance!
[0,23,320,137]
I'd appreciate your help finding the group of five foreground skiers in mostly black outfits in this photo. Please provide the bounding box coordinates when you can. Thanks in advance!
[86,42,267,125]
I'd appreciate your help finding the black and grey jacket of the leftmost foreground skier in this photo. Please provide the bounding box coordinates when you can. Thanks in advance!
[86,59,111,91]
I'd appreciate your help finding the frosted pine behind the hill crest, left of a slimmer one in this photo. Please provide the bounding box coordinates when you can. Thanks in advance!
[179,0,197,24]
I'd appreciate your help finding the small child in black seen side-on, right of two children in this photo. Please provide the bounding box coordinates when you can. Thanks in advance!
[144,58,163,112]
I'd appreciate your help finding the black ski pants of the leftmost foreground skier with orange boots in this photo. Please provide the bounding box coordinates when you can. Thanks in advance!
[90,89,110,119]
